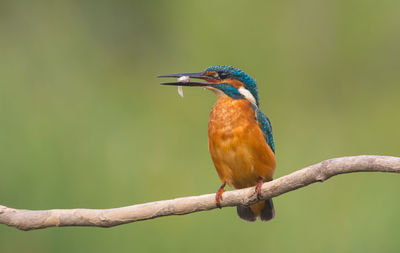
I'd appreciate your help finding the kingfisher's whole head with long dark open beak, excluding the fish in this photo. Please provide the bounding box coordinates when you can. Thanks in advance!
[159,65,258,106]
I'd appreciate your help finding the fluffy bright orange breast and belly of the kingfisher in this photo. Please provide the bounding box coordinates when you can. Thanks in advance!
[208,97,275,188]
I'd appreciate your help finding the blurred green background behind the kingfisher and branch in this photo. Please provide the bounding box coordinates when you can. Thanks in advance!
[0,0,400,252]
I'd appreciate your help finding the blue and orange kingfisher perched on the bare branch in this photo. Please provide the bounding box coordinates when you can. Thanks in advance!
[159,65,276,221]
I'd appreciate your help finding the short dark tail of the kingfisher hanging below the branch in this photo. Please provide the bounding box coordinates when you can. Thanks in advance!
[237,199,275,221]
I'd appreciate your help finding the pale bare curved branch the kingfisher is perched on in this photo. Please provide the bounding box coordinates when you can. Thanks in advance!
[0,155,400,230]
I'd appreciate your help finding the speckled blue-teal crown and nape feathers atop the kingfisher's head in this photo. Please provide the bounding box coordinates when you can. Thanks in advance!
[205,65,258,106]
